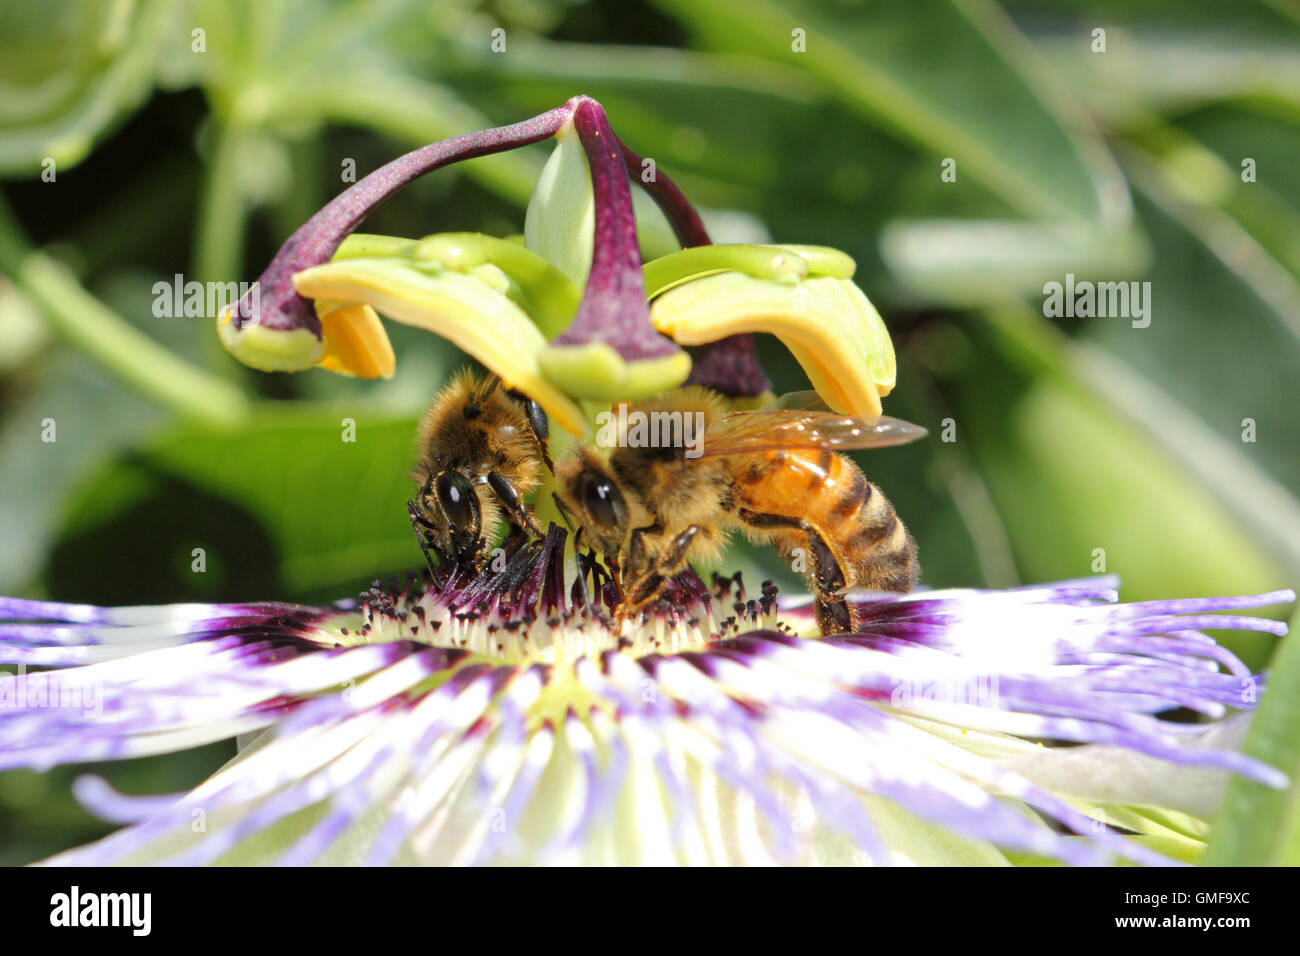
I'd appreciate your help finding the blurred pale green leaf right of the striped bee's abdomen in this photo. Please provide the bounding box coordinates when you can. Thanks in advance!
[951,311,1287,667]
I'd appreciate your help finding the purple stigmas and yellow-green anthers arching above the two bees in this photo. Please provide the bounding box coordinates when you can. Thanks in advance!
[217,96,894,436]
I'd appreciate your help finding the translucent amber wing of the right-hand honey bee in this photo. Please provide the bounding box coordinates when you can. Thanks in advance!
[699,408,928,458]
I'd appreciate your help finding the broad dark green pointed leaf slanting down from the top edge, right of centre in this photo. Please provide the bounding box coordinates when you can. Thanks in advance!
[650,0,1126,220]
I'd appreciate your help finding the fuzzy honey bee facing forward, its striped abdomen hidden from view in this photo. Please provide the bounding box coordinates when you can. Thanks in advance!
[407,369,551,571]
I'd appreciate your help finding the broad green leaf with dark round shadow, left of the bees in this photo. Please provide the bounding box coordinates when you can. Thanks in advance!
[44,405,421,604]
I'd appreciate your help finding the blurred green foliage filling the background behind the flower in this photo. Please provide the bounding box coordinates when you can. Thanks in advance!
[0,0,1300,862]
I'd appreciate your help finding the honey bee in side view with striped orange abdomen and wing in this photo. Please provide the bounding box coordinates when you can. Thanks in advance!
[555,386,926,635]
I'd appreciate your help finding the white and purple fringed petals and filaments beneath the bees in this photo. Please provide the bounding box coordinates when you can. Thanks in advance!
[0,525,1294,865]
